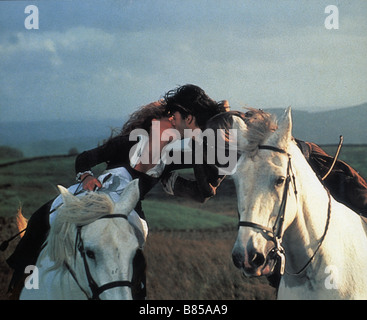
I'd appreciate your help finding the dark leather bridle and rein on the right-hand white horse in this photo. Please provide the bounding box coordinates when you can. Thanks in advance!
[238,145,331,275]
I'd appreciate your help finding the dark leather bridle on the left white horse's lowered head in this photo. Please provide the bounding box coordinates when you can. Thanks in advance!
[64,214,132,300]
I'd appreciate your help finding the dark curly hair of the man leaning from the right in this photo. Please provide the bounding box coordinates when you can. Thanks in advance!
[164,84,226,129]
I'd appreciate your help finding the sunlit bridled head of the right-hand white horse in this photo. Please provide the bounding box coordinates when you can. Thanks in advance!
[232,108,297,276]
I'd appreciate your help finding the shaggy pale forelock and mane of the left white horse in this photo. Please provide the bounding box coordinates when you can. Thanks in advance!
[44,193,114,269]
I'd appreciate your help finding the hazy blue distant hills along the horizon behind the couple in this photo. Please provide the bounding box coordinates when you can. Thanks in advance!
[0,103,367,157]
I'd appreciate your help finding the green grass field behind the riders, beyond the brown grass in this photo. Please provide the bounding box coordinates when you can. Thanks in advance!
[0,145,367,221]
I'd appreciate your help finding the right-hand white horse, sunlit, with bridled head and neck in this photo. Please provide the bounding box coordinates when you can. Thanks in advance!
[232,108,367,299]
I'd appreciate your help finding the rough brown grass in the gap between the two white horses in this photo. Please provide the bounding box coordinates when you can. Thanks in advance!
[145,231,275,300]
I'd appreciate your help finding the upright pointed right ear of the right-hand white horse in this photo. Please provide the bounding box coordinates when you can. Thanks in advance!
[267,107,292,149]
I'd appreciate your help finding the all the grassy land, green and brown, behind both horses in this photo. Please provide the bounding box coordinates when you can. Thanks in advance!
[0,146,367,299]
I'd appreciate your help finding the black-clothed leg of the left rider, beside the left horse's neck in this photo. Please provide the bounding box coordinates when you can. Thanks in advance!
[6,200,54,292]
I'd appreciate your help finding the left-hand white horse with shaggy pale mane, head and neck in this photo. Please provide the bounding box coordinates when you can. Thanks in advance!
[20,180,143,300]
